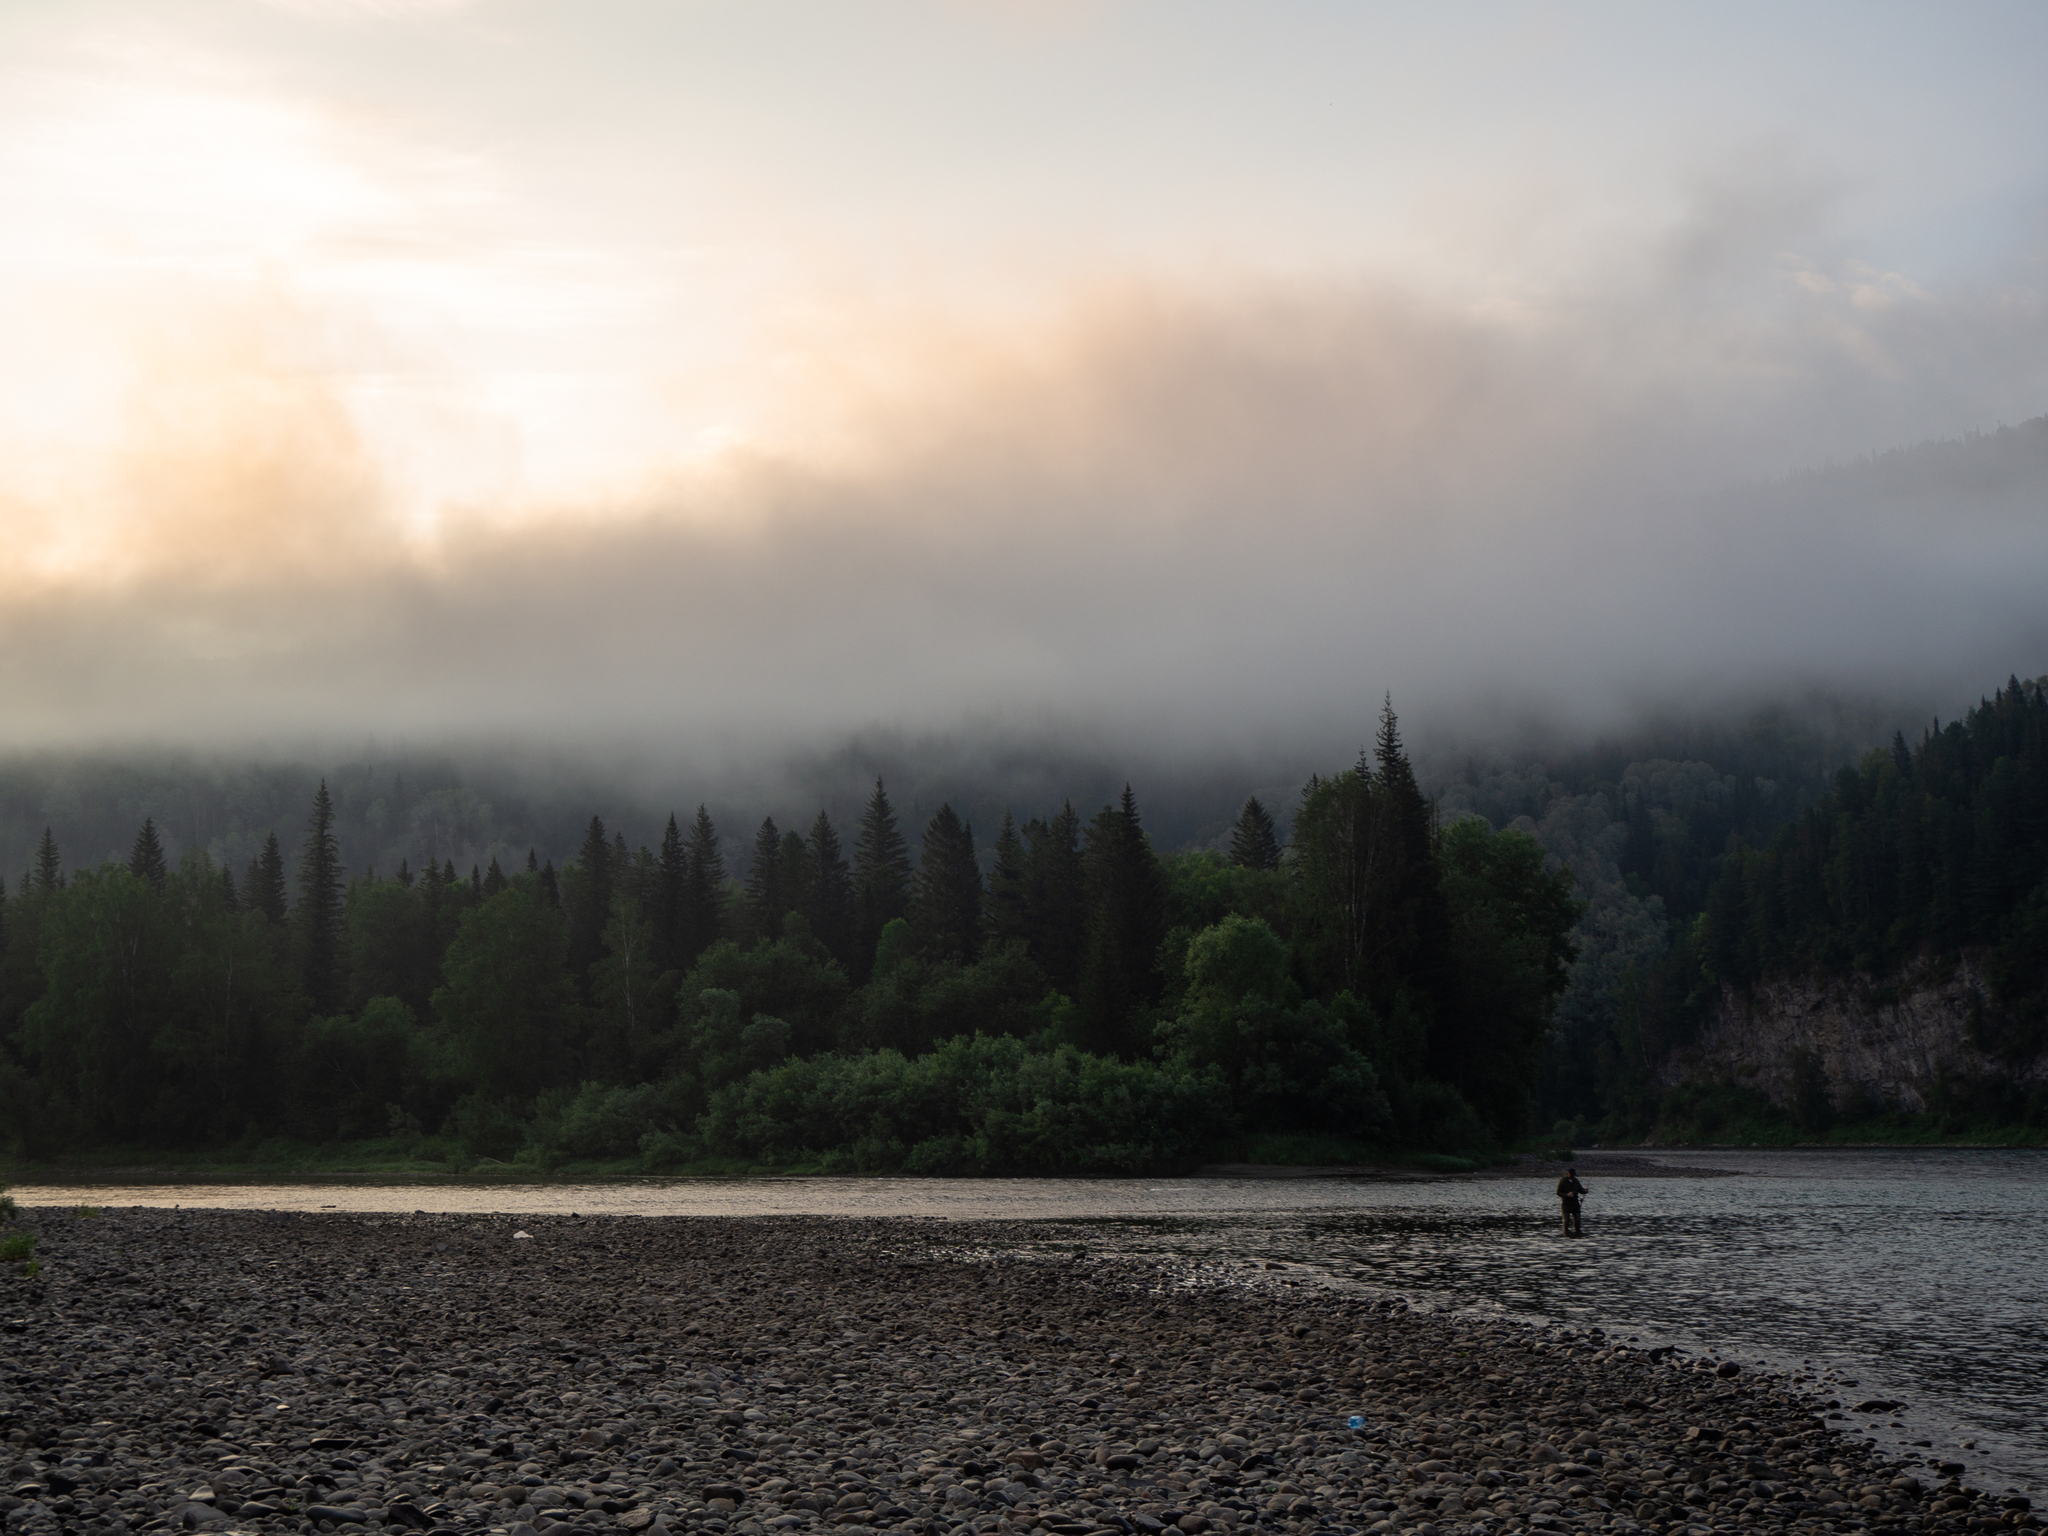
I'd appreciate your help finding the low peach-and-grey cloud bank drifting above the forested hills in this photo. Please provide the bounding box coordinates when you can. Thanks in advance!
[0,247,2048,762]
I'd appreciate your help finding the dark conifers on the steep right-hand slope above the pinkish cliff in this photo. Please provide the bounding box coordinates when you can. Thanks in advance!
[1579,678,2048,1130]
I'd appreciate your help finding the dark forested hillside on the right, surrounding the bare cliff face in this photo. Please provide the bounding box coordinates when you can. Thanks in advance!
[1490,678,2048,1137]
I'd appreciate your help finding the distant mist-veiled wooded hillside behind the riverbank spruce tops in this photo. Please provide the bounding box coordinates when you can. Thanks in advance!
[0,694,1927,901]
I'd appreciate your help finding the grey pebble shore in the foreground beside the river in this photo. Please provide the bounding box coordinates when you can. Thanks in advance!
[0,1210,2040,1536]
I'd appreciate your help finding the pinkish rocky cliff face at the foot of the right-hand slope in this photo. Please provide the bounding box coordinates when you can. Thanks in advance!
[1657,961,2048,1112]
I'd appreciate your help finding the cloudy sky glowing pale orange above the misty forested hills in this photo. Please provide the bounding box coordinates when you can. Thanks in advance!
[0,0,2048,762]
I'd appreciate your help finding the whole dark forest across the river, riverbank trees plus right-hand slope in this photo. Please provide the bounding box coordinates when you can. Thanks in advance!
[0,680,2048,1174]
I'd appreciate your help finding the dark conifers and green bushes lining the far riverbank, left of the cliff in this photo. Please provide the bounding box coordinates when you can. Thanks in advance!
[0,707,1579,1171]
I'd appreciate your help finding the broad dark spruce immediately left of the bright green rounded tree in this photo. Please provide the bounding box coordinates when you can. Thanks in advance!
[1079,784,1165,1057]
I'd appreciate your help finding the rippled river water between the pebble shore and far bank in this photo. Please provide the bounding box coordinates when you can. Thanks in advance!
[16,1151,2048,1491]
